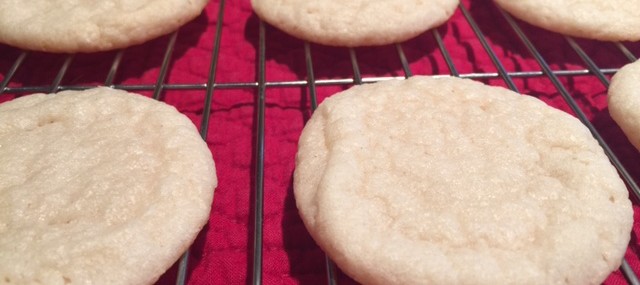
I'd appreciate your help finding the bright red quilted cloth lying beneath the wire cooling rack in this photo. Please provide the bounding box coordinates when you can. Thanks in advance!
[0,0,640,284]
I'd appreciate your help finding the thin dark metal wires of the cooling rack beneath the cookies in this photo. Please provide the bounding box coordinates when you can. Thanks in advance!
[0,0,640,284]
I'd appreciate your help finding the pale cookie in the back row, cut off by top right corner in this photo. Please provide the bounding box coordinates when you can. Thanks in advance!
[494,0,640,41]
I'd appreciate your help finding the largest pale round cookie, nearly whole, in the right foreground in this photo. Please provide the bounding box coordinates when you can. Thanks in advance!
[294,77,633,284]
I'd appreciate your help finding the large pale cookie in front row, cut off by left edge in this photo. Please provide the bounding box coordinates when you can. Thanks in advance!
[0,88,217,284]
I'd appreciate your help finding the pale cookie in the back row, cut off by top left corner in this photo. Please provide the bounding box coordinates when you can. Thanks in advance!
[0,0,208,53]
